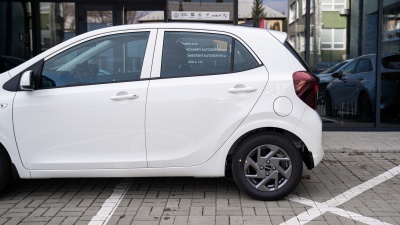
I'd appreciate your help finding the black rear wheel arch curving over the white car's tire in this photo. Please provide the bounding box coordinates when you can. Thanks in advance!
[225,127,314,170]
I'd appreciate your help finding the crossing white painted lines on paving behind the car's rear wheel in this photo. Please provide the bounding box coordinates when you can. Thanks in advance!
[281,163,400,225]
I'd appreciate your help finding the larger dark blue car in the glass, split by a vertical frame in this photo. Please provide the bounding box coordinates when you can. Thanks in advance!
[325,54,400,121]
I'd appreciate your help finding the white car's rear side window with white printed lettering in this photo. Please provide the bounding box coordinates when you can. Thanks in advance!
[161,32,260,77]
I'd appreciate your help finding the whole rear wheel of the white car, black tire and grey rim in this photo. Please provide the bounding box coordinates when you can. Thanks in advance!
[232,133,303,201]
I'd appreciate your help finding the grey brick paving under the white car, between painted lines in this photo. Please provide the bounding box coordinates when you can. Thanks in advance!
[0,153,400,225]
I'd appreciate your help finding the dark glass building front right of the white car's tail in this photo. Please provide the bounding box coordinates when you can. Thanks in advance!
[288,0,400,131]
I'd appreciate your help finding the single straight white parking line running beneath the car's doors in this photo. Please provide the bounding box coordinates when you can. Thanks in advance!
[89,178,133,225]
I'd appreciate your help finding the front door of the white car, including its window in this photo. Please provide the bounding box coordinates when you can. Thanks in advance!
[13,30,156,170]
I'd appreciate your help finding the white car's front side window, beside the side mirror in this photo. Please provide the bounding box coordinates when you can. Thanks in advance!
[39,32,149,88]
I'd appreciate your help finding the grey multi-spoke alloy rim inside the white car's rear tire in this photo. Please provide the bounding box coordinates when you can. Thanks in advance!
[243,144,292,191]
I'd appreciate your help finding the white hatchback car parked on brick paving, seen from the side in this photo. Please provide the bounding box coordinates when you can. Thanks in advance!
[0,23,324,200]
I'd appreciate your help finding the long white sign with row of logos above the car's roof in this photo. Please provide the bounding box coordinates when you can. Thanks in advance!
[171,11,229,20]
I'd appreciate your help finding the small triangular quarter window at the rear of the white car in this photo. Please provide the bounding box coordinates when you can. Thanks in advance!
[233,40,259,72]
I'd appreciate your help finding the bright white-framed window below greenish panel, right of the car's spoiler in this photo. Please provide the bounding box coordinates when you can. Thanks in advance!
[321,28,346,50]
